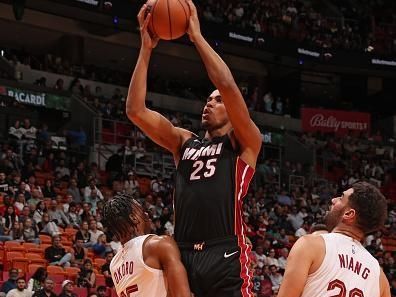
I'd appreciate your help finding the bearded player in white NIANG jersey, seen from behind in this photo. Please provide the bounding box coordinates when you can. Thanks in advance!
[277,182,391,297]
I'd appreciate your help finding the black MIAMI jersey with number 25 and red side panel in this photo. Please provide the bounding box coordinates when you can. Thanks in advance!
[174,135,254,243]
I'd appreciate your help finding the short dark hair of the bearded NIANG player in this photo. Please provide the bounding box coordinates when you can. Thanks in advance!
[349,182,388,234]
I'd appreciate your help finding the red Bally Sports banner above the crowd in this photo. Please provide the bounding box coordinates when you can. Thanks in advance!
[301,108,371,135]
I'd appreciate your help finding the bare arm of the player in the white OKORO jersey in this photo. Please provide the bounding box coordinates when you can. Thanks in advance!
[156,236,191,297]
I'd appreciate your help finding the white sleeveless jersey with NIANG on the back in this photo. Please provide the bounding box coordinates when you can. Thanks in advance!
[301,233,380,297]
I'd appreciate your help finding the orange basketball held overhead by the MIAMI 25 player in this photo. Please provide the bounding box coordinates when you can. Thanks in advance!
[147,0,190,40]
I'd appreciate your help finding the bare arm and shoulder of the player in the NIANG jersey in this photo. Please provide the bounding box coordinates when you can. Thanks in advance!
[277,236,321,297]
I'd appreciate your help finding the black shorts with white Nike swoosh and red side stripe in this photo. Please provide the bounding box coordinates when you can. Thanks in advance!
[178,236,253,297]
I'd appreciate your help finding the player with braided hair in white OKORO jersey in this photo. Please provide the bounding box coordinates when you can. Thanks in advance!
[103,194,191,297]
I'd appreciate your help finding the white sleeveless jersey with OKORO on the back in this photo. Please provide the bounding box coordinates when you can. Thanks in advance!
[110,234,167,297]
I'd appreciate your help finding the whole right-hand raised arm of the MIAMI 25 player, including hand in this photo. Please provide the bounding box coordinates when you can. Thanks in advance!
[186,0,262,167]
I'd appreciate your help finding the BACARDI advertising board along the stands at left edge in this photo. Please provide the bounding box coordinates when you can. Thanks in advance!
[0,86,71,111]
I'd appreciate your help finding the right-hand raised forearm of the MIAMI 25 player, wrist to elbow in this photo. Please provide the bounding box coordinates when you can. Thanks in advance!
[194,35,235,91]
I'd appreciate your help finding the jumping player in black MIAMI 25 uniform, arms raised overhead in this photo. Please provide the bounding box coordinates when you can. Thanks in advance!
[126,0,262,297]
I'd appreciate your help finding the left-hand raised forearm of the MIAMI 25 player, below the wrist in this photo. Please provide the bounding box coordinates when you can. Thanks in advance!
[126,48,151,118]
